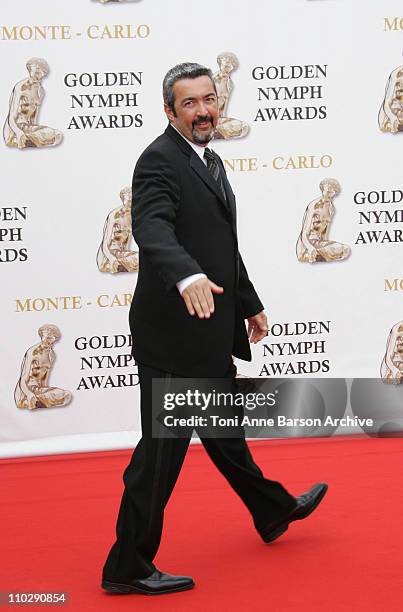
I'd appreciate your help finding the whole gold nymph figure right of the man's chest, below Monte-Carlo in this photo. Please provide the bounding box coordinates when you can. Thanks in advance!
[296,178,350,263]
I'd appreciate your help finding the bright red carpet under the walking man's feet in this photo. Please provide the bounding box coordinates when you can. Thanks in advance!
[0,438,403,612]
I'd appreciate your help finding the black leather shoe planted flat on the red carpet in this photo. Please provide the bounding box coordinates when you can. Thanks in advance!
[102,569,195,595]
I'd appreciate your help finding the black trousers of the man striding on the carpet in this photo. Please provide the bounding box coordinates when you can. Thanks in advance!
[103,364,296,582]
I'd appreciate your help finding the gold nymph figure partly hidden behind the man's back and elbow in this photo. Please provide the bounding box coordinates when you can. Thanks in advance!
[97,187,139,274]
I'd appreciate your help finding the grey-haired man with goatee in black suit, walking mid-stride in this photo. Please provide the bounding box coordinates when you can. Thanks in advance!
[102,63,327,594]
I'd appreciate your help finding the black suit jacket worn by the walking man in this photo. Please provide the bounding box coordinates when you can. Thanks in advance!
[130,126,263,377]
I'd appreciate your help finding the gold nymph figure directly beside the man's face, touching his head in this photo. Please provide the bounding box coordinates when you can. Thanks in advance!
[213,51,249,139]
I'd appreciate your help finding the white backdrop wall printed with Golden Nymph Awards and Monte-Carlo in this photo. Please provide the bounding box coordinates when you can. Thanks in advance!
[0,0,403,456]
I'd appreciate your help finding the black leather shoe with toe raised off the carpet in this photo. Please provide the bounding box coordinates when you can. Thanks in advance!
[258,482,328,543]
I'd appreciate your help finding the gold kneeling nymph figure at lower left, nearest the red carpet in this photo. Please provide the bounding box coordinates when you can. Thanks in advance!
[14,325,72,410]
